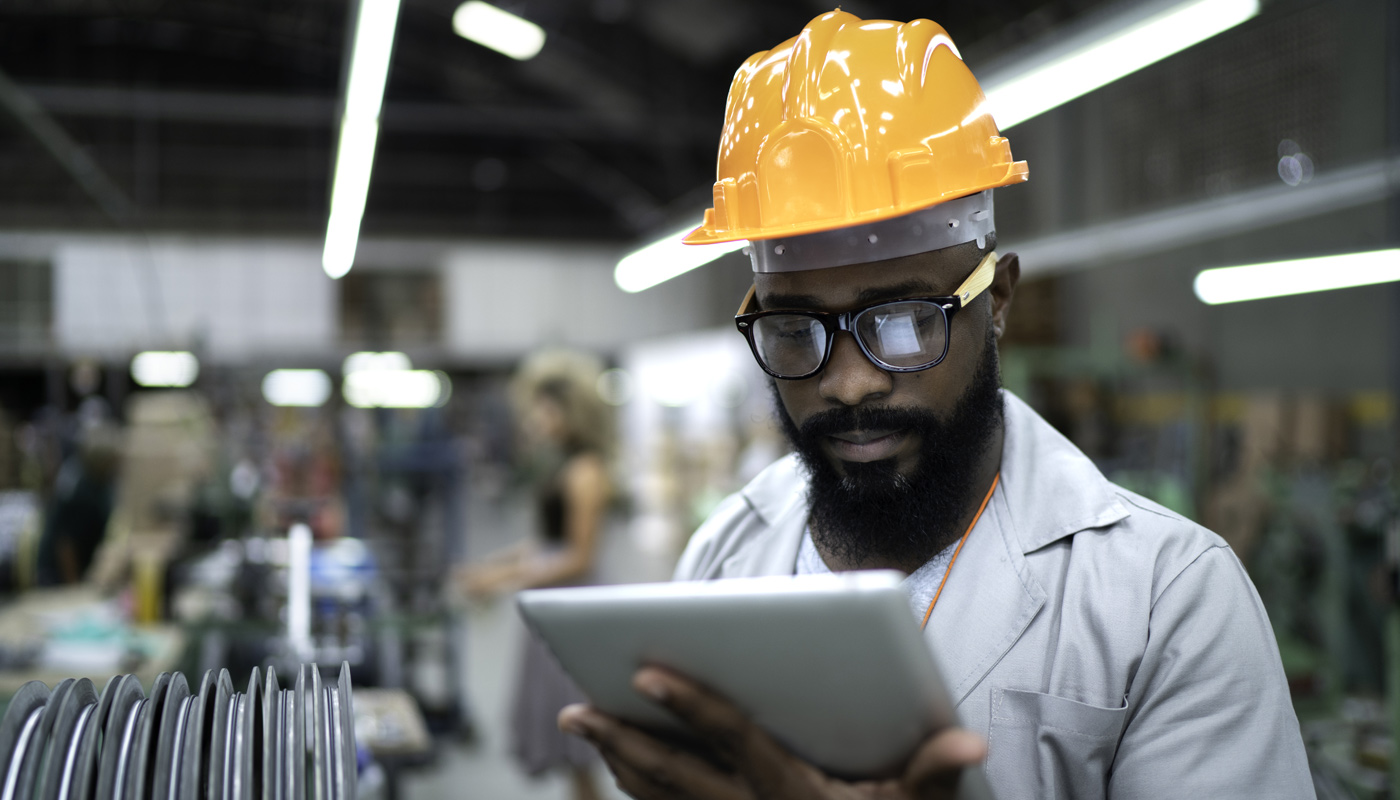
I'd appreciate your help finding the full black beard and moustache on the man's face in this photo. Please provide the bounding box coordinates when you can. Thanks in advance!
[773,331,1002,567]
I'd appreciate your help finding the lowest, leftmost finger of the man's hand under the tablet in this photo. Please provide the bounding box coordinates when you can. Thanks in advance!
[559,705,752,800]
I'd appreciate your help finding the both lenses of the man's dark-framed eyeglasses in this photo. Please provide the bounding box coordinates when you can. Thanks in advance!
[753,300,948,375]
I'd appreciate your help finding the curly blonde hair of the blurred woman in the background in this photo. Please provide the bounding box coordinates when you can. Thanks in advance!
[511,349,613,458]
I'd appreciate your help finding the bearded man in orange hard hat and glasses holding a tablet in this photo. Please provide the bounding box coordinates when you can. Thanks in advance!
[560,11,1313,800]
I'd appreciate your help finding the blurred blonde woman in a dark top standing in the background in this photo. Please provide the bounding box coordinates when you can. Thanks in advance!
[459,350,613,800]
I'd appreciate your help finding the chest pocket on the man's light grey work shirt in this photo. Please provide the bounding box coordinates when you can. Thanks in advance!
[987,689,1128,800]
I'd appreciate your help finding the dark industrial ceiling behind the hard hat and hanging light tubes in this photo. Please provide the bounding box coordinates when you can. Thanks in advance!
[0,0,1099,241]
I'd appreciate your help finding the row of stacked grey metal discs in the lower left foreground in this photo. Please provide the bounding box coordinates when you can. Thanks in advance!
[0,664,356,800]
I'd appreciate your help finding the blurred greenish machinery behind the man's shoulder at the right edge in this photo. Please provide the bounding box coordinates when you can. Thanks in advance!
[1002,302,1400,799]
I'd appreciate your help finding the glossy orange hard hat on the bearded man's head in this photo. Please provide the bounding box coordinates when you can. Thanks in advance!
[685,11,1026,252]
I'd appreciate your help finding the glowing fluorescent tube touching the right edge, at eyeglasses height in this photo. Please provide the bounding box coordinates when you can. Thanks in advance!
[1194,249,1400,305]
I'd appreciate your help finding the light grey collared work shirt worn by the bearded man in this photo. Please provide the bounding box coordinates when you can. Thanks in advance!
[676,392,1315,800]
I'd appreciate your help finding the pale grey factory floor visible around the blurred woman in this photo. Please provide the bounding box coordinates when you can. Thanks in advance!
[400,479,673,800]
